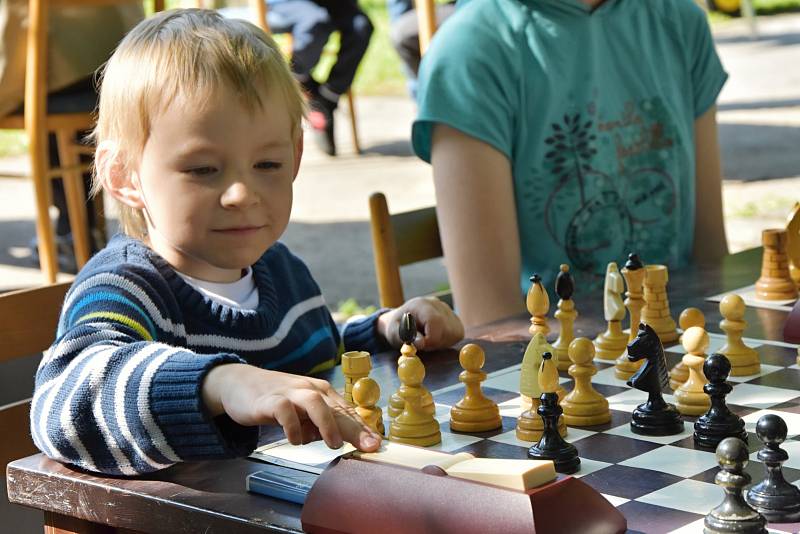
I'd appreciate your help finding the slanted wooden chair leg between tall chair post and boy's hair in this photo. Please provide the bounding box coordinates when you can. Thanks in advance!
[56,130,92,269]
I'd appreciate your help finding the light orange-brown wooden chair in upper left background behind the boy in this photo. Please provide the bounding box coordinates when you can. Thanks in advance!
[0,0,163,283]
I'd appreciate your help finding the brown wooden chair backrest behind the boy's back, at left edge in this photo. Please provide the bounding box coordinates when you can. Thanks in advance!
[0,282,70,472]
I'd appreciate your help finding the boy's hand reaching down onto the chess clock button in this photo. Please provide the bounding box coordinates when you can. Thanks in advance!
[202,363,381,452]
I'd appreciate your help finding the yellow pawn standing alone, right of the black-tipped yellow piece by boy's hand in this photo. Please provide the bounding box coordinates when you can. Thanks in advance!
[450,343,503,432]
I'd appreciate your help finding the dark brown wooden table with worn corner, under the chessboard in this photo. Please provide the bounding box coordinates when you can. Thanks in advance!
[8,249,786,534]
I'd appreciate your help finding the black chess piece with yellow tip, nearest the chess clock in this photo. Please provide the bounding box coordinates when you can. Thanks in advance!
[528,352,581,475]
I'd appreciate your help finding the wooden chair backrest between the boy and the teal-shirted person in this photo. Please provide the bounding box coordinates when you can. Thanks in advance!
[369,193,443,308]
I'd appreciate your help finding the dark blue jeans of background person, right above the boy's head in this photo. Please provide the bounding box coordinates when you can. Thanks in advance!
[268,0,372,95]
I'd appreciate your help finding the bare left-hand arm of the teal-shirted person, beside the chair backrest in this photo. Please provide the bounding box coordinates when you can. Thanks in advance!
[431,124,524,327]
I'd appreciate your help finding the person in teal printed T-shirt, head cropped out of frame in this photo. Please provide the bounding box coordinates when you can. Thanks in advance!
[412,0,727,325]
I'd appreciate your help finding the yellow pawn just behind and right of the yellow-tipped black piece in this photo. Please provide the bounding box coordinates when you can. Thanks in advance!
[561,337,611,426]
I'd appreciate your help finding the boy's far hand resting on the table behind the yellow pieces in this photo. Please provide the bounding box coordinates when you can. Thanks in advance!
[378,297,464,350]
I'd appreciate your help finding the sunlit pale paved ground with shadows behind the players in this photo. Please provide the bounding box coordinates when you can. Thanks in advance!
[0,15,800,307]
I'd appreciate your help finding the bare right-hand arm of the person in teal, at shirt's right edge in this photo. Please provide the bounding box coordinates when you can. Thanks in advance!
[692,106,728,262]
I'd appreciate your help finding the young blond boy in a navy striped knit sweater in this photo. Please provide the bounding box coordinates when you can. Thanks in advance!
[31,10,463,475]
